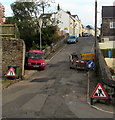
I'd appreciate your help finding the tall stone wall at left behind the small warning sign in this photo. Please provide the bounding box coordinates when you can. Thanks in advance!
[2,37,25,77]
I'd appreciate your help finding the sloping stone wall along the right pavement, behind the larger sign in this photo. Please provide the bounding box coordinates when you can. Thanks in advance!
[95,39,115,88]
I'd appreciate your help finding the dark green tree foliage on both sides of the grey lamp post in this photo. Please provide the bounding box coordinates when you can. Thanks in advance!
[10,1,58,50]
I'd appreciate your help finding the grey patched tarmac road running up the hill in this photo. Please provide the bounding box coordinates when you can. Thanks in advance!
[3,37,113,118]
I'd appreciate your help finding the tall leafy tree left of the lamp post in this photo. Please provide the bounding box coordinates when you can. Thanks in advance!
[11,2,39,49]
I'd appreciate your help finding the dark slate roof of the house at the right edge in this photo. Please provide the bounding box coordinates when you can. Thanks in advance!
[102,6,115,18]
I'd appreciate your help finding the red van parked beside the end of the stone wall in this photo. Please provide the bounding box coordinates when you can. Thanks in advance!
[26,50,46,69]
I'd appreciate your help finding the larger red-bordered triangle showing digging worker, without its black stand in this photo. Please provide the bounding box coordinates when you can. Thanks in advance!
[91,83,109,99]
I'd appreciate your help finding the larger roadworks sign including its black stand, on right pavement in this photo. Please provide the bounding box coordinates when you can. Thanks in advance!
[91,83,109,105]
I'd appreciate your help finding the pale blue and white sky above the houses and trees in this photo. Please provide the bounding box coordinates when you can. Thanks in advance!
[0,0,115,27]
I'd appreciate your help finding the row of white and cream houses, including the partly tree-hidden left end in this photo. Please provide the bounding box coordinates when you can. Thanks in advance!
[41,9,82,36]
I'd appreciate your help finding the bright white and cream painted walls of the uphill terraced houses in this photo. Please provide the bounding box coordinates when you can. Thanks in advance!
[51,10,82,36]
